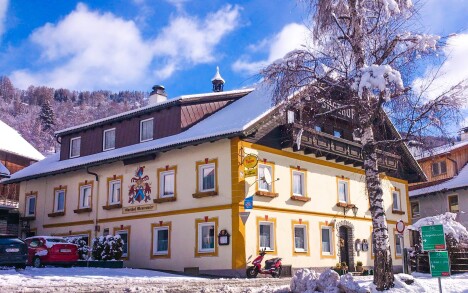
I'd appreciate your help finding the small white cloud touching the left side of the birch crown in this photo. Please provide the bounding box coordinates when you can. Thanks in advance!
[232,23,310,75]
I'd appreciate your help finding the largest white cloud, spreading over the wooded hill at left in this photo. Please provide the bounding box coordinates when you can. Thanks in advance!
[11,4,240,89]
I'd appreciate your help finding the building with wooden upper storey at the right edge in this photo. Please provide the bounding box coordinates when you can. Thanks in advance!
[409,127,468,227]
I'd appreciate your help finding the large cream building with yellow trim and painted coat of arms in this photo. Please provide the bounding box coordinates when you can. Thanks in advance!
[8,72,424,275]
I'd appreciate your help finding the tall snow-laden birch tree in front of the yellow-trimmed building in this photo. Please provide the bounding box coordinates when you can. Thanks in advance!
[262,0,466,290]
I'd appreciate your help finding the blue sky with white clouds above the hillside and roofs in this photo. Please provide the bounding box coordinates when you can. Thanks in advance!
[0,0,468,102]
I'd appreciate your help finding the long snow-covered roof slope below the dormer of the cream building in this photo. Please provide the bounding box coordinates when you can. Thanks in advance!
[4,85,274,183]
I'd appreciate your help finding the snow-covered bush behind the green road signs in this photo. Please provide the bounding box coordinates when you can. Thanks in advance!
[408,212,468,242]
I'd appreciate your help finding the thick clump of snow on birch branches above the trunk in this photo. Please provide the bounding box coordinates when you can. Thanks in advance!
[353,64,403,99]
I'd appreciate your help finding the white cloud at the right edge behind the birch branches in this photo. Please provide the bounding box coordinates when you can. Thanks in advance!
[413,33,468,106]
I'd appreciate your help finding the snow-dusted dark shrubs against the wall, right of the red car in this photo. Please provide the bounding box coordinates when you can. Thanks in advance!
[91,235,123,260]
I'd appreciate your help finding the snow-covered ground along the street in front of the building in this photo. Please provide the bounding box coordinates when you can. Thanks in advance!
[0,267,468,293]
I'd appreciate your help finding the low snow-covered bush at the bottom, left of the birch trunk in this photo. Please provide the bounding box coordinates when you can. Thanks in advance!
[290,269,369,293]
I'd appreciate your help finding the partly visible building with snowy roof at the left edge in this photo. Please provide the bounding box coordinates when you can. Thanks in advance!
[0,120,44,234]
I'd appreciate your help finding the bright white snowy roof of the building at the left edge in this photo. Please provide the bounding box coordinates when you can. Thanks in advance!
[0,120,44,161]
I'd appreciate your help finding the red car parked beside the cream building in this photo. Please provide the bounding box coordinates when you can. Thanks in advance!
[24,236,78,268]
